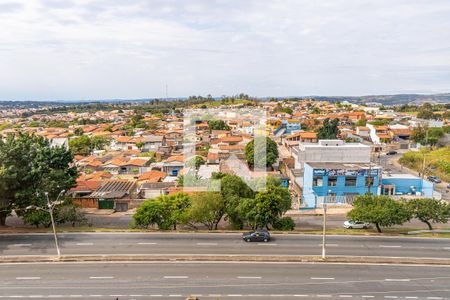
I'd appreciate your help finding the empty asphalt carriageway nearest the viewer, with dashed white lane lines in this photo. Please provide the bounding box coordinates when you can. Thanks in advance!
[0,262,450,300]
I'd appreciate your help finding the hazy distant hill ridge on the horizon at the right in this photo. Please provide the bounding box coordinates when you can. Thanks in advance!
[305,93,450,105]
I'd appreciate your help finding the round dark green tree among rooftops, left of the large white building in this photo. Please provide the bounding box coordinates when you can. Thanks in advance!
[245,137,278,167]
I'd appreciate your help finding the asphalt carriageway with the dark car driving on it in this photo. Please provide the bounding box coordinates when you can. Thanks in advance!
[0,232,450,258]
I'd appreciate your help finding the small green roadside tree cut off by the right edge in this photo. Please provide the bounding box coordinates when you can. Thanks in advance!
[407,198,450,230]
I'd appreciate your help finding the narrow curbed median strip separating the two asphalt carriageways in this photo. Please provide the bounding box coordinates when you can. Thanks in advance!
[0,255,450,266]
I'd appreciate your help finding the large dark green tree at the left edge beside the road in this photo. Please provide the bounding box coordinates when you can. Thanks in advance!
[0,133,77,226]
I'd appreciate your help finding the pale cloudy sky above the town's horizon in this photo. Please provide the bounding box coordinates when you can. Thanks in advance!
[0,0,450,100]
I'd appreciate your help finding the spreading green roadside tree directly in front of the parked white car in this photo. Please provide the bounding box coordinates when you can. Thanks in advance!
[347,194,411,232]
